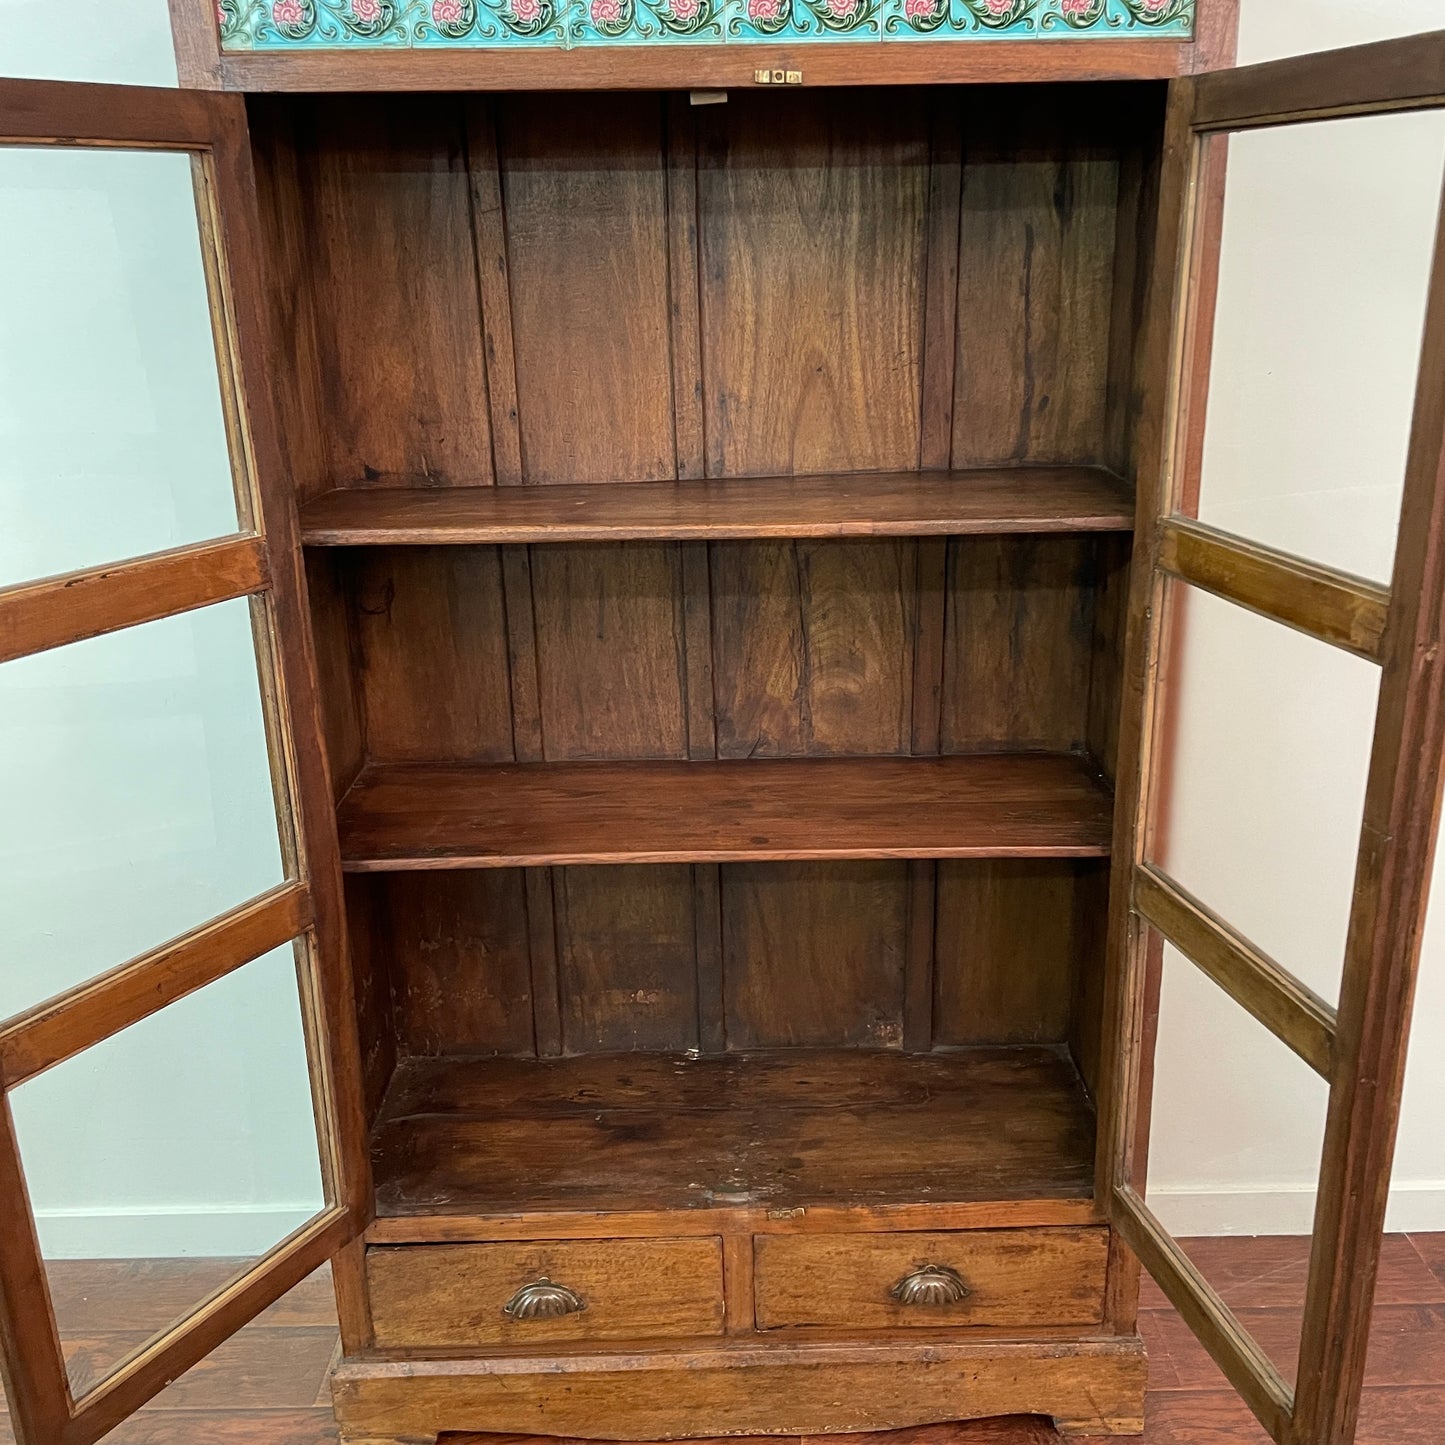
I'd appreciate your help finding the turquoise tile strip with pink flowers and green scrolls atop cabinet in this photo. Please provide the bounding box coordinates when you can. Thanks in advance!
[214,0,1195,51]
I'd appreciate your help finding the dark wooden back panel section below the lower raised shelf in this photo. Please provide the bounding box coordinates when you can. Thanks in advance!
[367,860,1086,1056]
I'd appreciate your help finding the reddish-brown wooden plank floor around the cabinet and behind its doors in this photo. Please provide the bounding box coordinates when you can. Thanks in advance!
[0,1234,1445,1445]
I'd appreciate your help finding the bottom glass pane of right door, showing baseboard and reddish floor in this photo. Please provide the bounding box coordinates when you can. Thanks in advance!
[1140,946,1329,1392]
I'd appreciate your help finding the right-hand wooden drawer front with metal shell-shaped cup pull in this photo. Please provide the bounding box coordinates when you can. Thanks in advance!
[754,1228,1108,1329]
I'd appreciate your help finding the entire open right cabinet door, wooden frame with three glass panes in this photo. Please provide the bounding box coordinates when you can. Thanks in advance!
[1098,32,1445,1445]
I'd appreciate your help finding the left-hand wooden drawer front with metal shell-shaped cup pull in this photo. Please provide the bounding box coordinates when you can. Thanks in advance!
[366,1238,723,1348]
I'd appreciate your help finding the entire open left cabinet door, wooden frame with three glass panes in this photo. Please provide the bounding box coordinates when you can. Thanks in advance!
[0,81,364,1445]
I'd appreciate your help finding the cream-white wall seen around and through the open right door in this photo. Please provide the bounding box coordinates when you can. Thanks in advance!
[1149,0,1445,1234]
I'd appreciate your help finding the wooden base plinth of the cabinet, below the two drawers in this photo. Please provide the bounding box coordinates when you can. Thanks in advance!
[332,1337,1146,1445]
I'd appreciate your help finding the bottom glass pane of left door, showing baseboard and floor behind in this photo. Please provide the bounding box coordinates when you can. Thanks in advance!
[10,945,325,1396]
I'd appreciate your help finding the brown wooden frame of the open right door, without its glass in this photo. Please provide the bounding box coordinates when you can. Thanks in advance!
[1097,32,1445,1445]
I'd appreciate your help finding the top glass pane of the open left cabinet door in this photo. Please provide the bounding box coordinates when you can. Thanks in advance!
[0,146,237,585]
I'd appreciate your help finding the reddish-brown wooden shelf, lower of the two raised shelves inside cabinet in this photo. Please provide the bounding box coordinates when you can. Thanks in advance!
[338,753,1113,873]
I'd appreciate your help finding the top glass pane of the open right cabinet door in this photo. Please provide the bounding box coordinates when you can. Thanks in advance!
[1198,111,1445,581]
